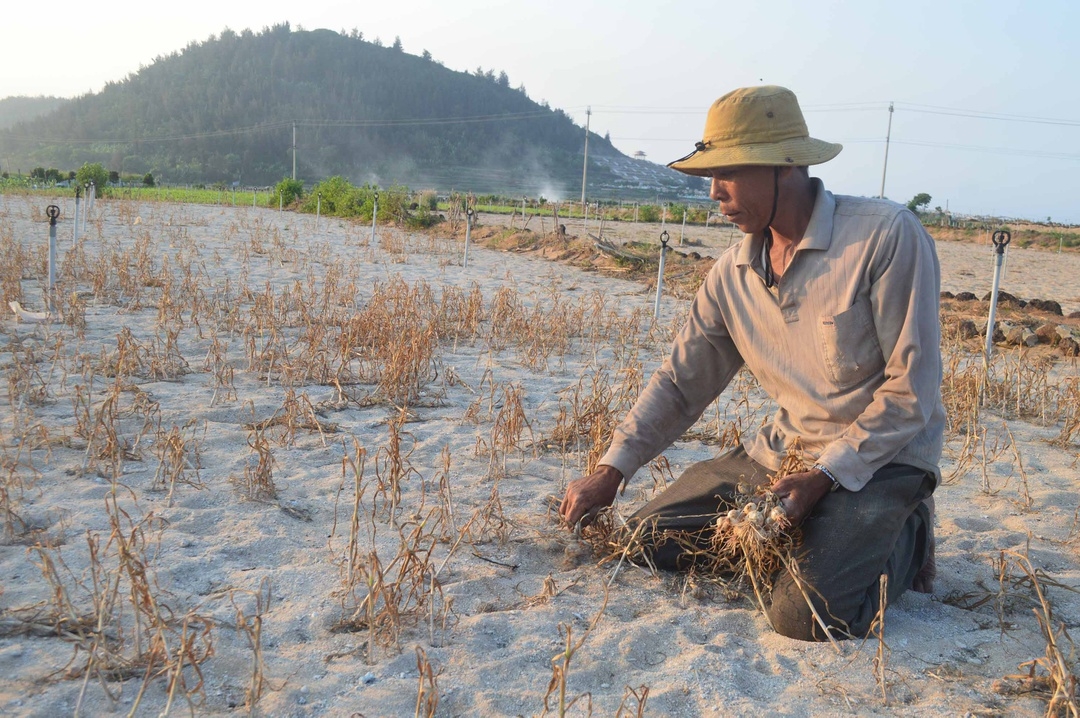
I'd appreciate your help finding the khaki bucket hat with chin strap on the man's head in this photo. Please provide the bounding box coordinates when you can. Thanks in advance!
[667,85,843,177]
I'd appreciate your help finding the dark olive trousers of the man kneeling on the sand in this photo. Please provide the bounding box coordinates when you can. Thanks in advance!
[631,447,934,640]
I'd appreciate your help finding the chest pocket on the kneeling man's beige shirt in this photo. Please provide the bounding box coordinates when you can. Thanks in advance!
[819,300,885,389]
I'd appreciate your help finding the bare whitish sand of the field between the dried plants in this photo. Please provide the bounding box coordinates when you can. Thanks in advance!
[0,197,1080,716]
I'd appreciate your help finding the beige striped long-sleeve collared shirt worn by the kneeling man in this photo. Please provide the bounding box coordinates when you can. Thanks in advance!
[600,179,945,491]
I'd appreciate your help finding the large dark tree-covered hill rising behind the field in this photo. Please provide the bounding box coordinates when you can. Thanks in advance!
[0,24,697,197]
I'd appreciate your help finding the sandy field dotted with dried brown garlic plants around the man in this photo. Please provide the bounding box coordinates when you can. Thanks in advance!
[0,197,1080,717]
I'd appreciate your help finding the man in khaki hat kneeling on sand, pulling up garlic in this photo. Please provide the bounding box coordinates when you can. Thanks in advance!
[559,86,945,640]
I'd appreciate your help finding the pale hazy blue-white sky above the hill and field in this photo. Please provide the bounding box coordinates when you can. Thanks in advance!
[0,0,1080,222]
